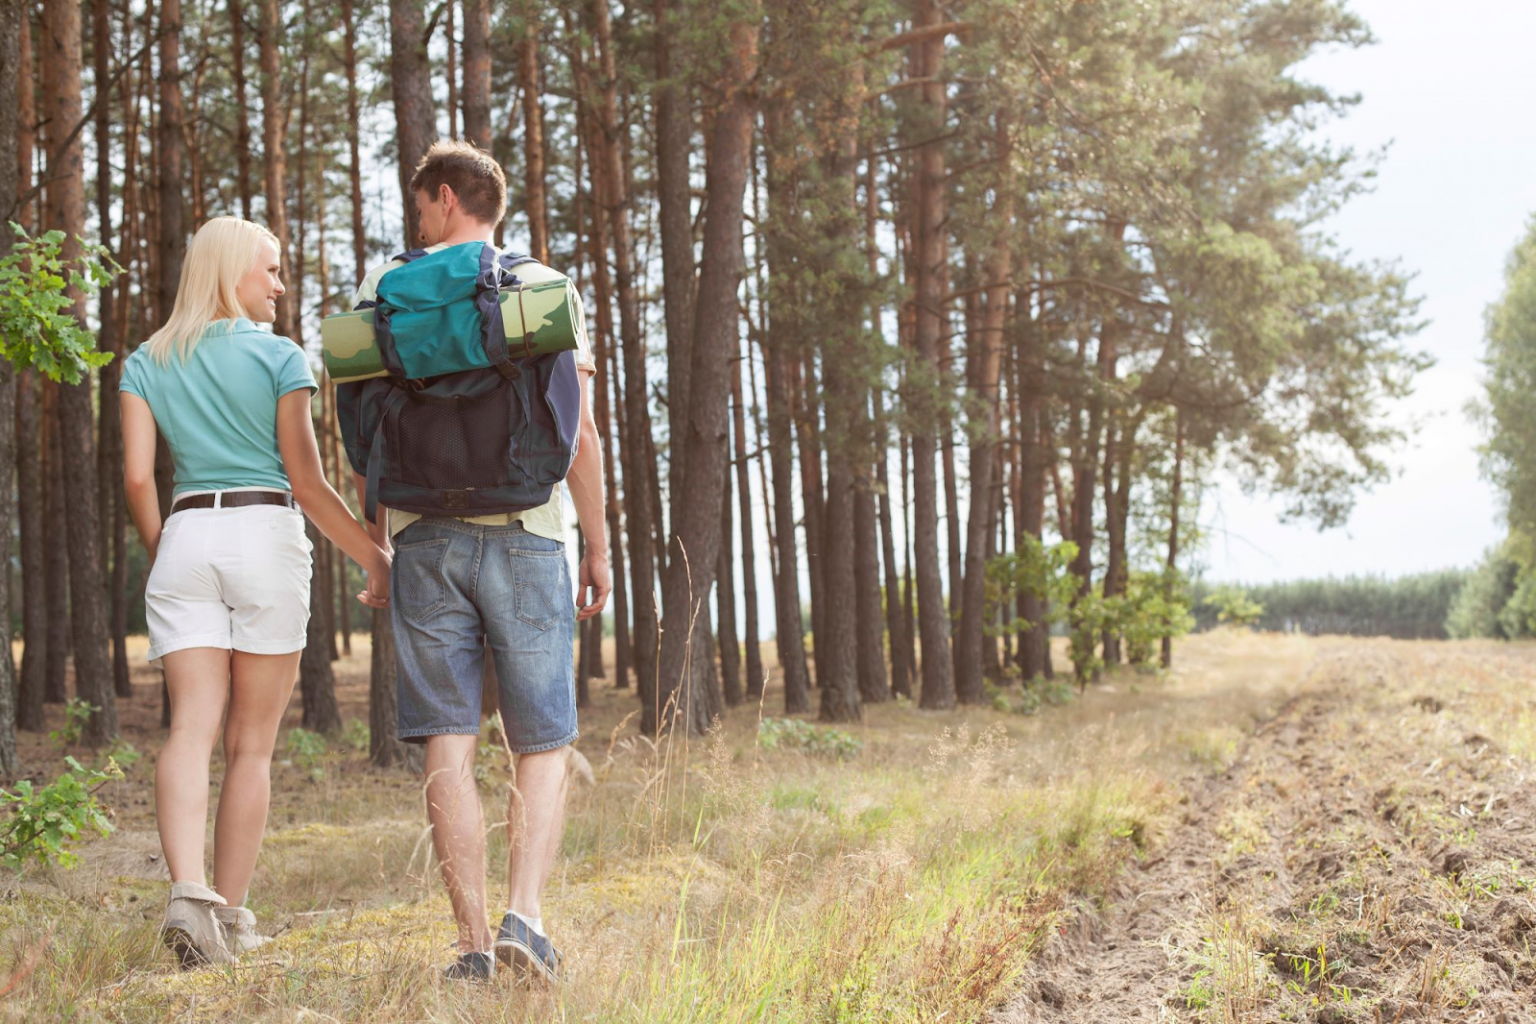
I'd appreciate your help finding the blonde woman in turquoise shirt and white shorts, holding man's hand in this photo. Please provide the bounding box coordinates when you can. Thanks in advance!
[121,216,390,966]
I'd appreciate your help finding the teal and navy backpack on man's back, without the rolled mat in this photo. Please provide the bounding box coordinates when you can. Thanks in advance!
[336,243,581,522]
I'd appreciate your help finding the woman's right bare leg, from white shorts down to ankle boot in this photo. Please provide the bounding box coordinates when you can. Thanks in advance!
[214,651,300,907]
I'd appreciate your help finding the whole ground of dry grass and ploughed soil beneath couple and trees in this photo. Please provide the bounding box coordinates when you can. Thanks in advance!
[0,631,1536,1024]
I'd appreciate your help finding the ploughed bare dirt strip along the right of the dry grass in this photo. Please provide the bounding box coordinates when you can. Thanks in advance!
[994,642,1536,1024]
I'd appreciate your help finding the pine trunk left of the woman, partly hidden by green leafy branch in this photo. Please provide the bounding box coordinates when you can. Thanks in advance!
[40,0,115,745]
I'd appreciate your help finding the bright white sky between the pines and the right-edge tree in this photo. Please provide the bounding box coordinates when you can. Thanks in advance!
[1201,0,1536,582]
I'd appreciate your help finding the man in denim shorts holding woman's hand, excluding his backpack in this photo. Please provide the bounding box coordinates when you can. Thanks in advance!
[353,141,611,981]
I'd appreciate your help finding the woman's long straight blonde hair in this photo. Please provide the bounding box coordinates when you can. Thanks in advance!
[144,216,278,365]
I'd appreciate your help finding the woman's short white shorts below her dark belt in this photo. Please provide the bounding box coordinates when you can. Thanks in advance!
[144,505,313,665]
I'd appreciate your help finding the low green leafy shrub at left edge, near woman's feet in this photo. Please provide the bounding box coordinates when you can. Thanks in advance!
[0,757,123,870]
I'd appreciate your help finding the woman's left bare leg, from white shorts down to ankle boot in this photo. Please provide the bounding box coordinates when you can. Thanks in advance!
[155,648,229,886]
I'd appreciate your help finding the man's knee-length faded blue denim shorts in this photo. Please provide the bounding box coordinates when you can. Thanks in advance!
[390,516,576,754]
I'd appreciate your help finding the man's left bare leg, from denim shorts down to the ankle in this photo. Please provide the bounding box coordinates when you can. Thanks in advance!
[427,735,492,953]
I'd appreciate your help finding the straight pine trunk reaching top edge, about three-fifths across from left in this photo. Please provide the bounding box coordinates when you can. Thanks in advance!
[906,0,955,708]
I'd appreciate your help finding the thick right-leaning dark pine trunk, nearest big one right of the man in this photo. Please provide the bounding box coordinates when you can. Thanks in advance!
[657,14,757,734]
